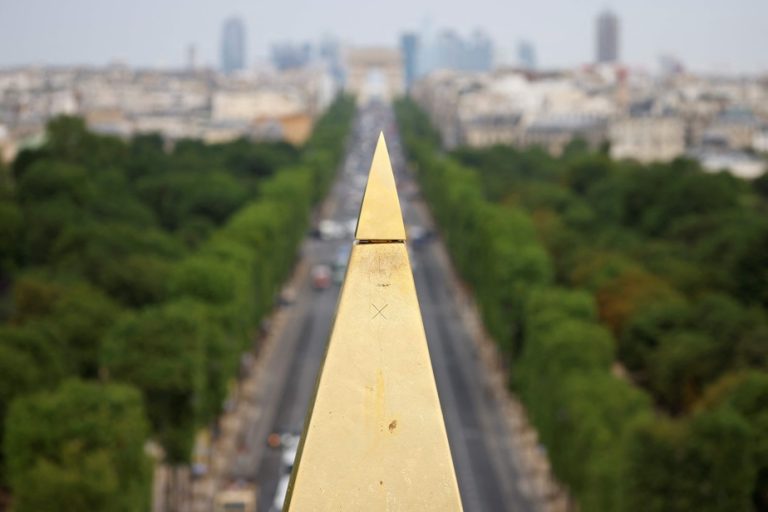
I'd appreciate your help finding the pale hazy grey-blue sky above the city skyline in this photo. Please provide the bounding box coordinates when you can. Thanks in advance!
[0,0,768,72]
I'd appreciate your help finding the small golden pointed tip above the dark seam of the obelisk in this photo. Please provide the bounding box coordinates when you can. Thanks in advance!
[355,132,405,241]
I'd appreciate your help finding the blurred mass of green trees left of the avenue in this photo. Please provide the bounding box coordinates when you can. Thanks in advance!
[0,98,354,512]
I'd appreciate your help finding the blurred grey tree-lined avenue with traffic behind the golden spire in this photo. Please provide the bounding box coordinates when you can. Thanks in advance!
[226,104,533,512]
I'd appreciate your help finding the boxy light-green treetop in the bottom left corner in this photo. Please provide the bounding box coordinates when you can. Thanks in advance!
[5,380,150,512]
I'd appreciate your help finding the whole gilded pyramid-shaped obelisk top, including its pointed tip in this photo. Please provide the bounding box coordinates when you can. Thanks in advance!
[284,134,462,512]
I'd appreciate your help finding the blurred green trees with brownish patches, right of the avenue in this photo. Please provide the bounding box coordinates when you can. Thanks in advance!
[396,100,768,512]
